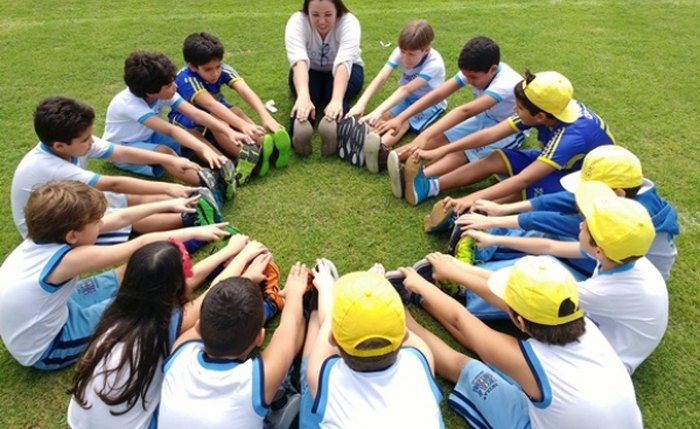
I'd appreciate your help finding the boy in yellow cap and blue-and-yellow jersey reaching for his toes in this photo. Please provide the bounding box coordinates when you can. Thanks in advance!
[405,71,615,207]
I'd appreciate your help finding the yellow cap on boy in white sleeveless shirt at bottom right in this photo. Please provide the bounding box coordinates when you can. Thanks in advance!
[488,256,583,326]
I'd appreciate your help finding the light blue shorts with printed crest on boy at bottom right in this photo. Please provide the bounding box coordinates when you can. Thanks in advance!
[447,359,530,429]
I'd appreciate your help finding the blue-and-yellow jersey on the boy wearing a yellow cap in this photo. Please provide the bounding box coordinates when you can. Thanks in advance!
[508,102,615,171]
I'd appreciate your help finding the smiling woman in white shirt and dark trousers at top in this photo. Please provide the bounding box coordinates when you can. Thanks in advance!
[284,0,364,155]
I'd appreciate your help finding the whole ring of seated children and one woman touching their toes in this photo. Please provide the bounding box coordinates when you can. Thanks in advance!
[0,0,679,428]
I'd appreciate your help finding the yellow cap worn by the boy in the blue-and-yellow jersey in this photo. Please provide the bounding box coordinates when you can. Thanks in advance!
[523,71,580,123]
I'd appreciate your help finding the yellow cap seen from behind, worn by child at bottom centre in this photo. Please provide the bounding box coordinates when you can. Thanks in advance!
[331,271,406,357]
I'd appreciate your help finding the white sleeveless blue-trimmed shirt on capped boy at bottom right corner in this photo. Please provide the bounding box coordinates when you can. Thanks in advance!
[520,319,642,429]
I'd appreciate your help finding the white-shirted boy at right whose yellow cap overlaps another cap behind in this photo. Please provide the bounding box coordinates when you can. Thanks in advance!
[454,181,668,374]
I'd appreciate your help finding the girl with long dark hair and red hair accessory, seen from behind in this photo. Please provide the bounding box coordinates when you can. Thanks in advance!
[67,235,270,429]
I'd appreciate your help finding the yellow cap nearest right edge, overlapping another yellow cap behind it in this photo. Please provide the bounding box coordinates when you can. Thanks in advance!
[575,181,656,263]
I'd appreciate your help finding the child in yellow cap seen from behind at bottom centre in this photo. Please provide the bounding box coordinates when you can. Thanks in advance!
[300,260,443,428]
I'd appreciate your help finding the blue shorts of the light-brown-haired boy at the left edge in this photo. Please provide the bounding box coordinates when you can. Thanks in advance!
[32,270,119,371]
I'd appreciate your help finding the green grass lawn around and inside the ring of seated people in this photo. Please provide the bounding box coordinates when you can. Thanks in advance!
[0,0,700,428]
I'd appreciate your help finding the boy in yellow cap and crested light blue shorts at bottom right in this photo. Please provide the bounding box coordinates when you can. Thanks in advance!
[402,256,642,429]
